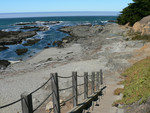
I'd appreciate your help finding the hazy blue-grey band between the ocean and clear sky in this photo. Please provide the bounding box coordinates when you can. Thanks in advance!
[0,11,120,19]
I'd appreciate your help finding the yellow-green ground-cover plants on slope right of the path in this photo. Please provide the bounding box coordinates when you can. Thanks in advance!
[114,57,150,105]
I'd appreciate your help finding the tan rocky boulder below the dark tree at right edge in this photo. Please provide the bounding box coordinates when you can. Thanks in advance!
[132,16,150,35]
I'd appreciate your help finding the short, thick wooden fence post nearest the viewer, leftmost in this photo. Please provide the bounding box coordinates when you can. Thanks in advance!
[21,92,33,113]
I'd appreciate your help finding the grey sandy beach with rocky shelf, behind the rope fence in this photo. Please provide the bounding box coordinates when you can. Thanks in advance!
[0,24,146,113]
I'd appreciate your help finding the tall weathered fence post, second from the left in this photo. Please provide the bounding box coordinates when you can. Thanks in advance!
[51,73,60,113]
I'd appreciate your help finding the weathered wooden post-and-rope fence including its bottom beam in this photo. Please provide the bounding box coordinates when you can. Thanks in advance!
[0,70,106,113]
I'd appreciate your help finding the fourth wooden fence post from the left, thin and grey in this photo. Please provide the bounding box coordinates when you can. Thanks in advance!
[84,72,88,99]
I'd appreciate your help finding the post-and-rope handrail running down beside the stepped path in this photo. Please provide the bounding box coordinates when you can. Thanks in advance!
[0,70,106,113]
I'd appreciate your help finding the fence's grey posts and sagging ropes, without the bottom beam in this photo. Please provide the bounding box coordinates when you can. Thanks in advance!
[0,70,103,113]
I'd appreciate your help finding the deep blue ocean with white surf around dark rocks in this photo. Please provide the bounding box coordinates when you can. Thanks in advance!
[0,16,117,61]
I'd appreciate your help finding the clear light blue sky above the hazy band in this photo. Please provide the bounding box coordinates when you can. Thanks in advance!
[0,0,132,13]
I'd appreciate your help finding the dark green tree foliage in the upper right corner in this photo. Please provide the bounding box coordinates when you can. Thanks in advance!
[117,0,150,26]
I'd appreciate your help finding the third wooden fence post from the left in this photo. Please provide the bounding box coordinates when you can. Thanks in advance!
[72,72,78,107]
